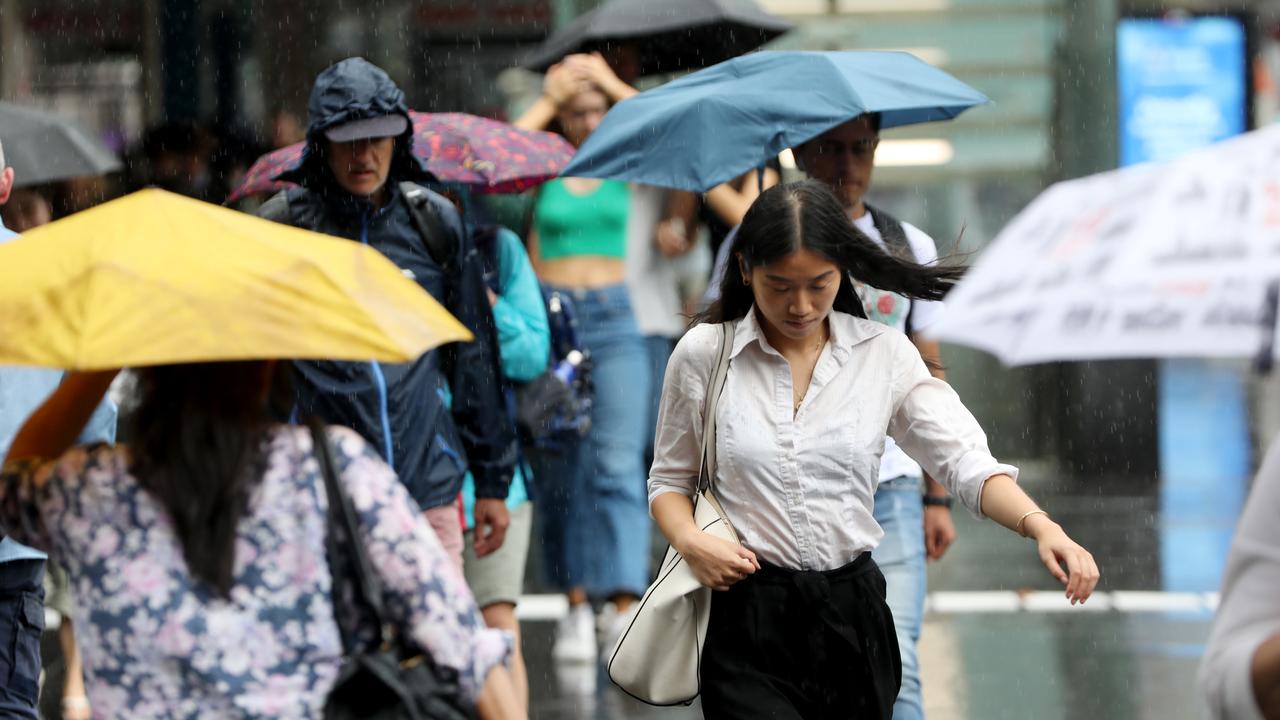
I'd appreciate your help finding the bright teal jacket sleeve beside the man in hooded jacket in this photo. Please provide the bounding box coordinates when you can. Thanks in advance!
[493,228,552,382]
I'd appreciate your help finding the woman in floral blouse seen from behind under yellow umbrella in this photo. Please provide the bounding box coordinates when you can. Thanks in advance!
[0,361,521,717]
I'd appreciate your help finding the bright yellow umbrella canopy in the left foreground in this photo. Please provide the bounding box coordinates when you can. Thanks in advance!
[0,190,471,370]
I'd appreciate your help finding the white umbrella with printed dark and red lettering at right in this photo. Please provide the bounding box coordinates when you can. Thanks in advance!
[927,127,1280,365]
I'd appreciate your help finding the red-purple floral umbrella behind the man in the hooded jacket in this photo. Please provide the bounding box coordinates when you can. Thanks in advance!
[227,113,573,202]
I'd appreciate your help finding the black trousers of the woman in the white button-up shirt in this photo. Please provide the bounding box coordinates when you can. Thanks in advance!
[701,552,902,720]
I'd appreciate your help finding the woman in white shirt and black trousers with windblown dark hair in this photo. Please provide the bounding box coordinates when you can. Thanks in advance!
[649,181,1098,720]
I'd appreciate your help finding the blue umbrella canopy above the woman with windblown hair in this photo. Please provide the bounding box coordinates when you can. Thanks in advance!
[564,51,988,192]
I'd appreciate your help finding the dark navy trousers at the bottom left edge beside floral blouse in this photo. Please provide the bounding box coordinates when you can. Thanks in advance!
[0,560,45,720]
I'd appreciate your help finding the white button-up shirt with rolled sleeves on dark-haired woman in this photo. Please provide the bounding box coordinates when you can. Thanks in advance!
[649,309,1018,570]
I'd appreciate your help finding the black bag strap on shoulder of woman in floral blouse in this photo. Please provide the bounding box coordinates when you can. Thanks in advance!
[307,418,389,642]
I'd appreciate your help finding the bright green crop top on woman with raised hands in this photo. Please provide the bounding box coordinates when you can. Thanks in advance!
[534,179,631,260]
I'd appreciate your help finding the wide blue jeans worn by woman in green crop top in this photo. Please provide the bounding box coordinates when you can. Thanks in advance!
[534,286,653,598]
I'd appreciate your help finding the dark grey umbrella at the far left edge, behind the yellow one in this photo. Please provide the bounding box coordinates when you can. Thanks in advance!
[0,102,120,187]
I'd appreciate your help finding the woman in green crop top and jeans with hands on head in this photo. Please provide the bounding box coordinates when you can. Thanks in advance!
[515,55,678,661]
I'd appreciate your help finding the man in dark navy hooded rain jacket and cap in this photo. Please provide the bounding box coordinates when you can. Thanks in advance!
[259,58,517,561]
